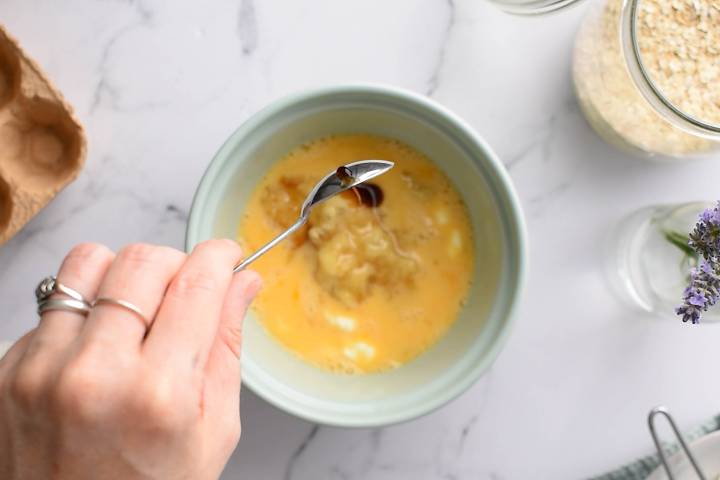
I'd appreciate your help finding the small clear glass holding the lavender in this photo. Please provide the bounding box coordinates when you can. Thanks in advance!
[606,202,720,323]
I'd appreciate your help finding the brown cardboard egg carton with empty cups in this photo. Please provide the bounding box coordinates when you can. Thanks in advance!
[0,27,87,245]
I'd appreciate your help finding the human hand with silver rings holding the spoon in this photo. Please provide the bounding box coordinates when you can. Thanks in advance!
[0,240,260,480]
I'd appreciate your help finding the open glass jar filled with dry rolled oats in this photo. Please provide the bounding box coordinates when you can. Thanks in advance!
[573,0,720,158]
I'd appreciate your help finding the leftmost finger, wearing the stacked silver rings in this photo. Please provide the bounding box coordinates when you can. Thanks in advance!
[31,243,115,349]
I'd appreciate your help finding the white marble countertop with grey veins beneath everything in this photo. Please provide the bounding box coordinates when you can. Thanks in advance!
[0,0,720,480]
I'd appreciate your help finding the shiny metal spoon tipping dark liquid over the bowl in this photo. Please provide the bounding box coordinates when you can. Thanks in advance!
[233,160,395,272]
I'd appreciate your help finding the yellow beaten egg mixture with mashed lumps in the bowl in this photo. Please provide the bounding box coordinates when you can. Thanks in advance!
[239,135,474,373]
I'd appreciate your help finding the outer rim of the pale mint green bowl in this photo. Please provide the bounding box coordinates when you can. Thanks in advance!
[185,83,528,428]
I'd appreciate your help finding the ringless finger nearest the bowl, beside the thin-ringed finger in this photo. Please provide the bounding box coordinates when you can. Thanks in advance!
[144,240,241,371]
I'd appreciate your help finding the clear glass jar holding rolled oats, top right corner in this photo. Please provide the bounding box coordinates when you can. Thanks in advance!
[573,0,720,159]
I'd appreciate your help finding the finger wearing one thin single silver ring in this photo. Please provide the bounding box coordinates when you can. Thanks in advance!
[82,244,186,351]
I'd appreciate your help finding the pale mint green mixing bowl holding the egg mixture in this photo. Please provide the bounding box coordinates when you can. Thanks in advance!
[186,85,527,427]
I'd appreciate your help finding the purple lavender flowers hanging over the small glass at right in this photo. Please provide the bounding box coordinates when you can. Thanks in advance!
[675,202,720,323]
